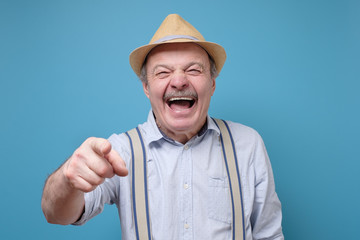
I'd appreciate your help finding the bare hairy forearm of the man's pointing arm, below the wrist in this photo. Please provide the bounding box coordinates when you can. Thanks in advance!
[41,165,85,225]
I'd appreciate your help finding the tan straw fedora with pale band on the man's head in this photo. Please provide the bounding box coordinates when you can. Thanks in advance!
[130,14,226,76]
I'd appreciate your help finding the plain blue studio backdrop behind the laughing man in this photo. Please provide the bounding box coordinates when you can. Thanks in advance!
[0,0,360,240]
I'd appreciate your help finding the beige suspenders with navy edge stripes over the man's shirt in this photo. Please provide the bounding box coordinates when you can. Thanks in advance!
[126,119,245,240]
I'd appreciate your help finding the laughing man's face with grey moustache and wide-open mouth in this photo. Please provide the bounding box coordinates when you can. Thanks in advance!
[143,43,215,143]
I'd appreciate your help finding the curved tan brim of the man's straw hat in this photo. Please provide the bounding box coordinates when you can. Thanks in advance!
[129,39,226,76]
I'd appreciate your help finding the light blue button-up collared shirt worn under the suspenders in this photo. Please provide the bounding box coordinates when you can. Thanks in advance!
[75,111,284,240]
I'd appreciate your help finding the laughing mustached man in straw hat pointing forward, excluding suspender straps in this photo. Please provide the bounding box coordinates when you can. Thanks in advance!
[42,14,283,240]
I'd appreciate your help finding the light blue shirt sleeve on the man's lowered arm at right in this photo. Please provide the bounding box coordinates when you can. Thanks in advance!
[250,136,284,240]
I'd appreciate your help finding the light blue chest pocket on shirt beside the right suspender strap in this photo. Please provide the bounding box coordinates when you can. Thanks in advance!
[208,177,232,224]
